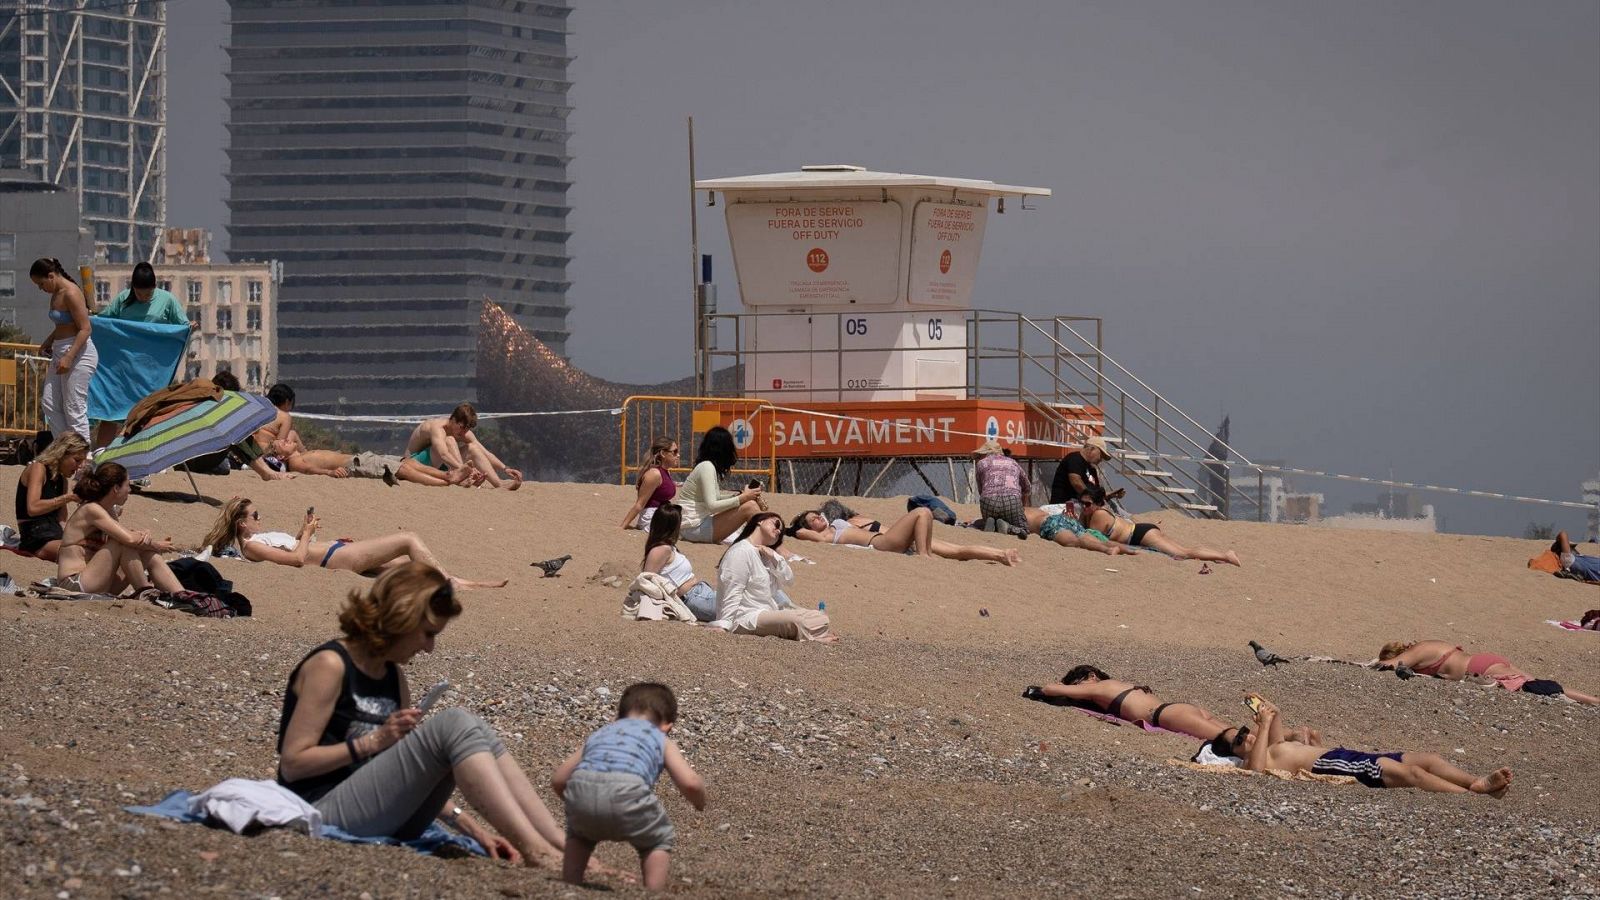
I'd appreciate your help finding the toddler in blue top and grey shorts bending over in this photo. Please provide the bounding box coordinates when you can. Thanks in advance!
[550,682,706,890]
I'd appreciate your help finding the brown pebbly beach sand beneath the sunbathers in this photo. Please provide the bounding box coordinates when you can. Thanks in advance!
[0,468,1600,897]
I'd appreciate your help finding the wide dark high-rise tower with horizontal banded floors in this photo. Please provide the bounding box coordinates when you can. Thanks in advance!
[227,0,571,415]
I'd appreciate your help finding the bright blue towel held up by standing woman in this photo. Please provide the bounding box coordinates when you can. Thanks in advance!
[90,315,189,421]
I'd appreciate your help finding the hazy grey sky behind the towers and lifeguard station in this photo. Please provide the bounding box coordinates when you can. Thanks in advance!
[168,0,1600,533]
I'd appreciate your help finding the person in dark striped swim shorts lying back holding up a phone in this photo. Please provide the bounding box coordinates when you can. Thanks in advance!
[1211,700,1510,799]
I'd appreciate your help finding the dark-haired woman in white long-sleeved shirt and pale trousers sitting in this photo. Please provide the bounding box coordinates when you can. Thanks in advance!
[717,512,838,644]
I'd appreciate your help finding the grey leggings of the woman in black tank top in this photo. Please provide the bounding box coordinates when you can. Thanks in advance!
[315,706,506,841]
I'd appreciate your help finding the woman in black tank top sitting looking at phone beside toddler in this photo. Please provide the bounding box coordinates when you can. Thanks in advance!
[278,560,588,870]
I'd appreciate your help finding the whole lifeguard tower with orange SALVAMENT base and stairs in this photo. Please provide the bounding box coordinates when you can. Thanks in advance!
[681,165,1254,517]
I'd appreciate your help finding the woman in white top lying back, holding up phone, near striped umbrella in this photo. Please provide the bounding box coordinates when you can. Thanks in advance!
[203,496,506,588]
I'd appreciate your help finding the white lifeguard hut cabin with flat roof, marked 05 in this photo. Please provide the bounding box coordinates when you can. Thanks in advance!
[694,165,1050,402]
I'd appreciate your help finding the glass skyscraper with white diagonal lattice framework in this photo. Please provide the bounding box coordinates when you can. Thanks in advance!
[0,0,166,261]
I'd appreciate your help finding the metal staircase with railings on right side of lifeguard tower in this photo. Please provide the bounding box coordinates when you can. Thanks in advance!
[968,309,1261,519]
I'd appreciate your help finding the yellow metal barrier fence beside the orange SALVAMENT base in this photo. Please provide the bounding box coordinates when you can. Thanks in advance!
[618,396,778,490]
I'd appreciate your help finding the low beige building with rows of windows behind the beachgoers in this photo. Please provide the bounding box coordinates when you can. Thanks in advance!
[94,229,278,391]
